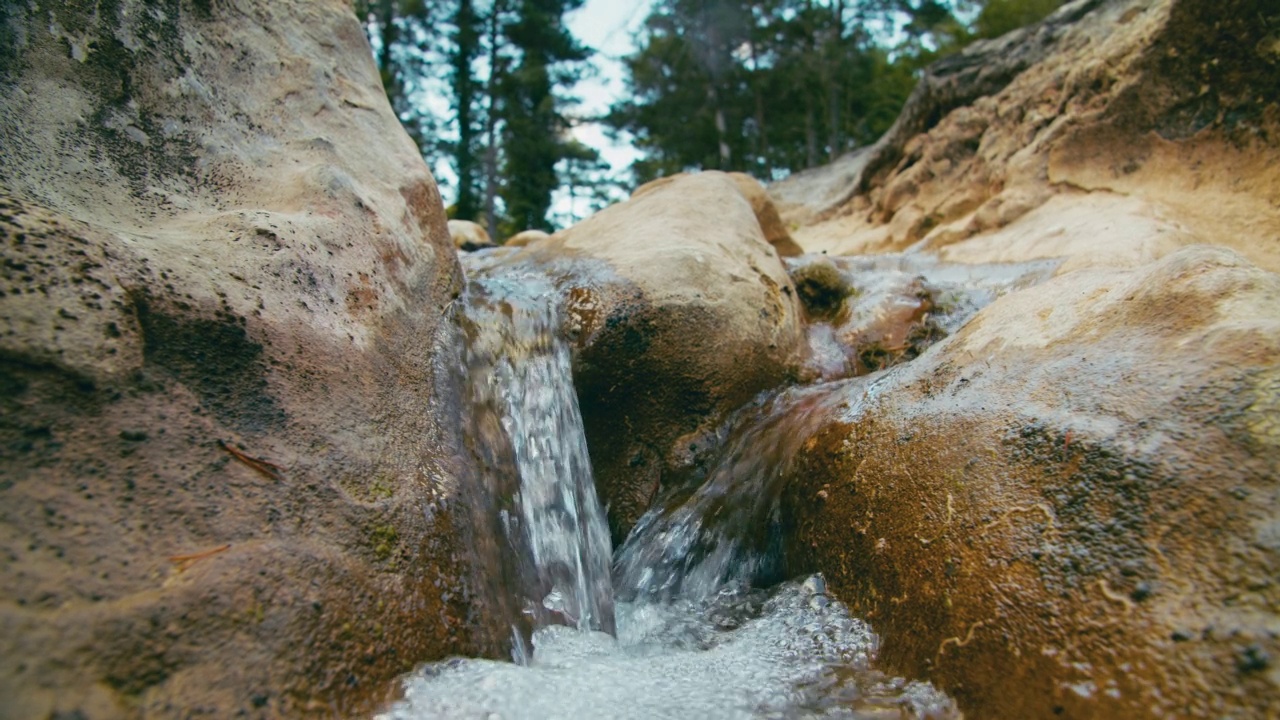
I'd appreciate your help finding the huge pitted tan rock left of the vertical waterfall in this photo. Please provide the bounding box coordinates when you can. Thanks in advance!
[0,0,506,719]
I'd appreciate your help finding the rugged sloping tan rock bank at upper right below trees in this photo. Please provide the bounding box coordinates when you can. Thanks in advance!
[776,0,1280,272]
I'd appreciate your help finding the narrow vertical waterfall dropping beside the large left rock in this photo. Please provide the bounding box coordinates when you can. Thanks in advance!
[467,267,614,633]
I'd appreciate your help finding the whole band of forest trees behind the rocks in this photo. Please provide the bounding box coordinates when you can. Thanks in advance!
[356,0,1061,237]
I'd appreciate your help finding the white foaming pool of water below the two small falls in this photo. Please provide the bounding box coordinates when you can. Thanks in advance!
[381,577,959,720]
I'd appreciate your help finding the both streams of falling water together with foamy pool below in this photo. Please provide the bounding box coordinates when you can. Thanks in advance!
[381,256,955,720]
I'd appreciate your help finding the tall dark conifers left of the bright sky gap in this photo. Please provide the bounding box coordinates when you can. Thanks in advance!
[356,0,588,234]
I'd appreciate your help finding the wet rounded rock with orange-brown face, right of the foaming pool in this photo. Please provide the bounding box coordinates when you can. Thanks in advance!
[783,246,1280,717]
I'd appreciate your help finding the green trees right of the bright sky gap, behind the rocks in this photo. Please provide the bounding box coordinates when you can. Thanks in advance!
[608,0,1060,183]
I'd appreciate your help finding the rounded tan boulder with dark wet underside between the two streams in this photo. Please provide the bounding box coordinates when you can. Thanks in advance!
[516,172,803,543]
